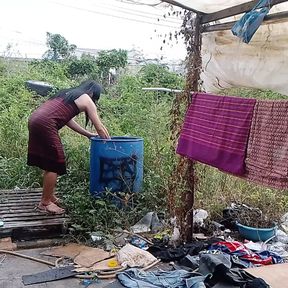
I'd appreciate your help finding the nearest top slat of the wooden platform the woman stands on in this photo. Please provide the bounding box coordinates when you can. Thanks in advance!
[0,217,69,231]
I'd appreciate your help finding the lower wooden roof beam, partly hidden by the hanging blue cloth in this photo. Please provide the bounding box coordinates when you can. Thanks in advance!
[202,11,288,33]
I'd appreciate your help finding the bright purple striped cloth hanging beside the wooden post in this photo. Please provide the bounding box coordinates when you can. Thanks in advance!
[177,93,256,175]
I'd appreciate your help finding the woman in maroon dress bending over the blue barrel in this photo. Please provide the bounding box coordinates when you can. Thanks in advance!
[27,81,110,214]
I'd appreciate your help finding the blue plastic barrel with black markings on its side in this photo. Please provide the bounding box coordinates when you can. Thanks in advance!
[90,136,144,196]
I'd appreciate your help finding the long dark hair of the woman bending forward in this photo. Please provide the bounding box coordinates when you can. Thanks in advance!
[52,80,102,126]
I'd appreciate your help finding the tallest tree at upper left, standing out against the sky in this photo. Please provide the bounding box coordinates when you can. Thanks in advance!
[43,32,77,61]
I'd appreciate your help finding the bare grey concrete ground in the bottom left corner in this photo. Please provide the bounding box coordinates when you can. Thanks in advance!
[0,248,114,288]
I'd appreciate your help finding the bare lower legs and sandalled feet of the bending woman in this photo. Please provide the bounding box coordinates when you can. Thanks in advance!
[39,171,65,214]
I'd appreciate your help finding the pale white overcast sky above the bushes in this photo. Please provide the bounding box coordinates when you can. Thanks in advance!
[0,0,185,60]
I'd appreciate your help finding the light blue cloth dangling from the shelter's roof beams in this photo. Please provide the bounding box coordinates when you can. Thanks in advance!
[231,0,271,43]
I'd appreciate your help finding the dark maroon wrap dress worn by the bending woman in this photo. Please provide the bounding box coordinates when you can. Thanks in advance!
[27,98,79,175]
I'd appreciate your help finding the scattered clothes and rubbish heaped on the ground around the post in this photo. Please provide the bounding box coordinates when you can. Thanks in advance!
[19,205,288,288]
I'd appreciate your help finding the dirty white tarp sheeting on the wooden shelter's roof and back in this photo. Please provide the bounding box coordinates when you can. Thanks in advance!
[162,0,288,95]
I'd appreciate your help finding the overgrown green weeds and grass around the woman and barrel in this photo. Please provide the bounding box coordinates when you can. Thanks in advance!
[0,56,288,231]
